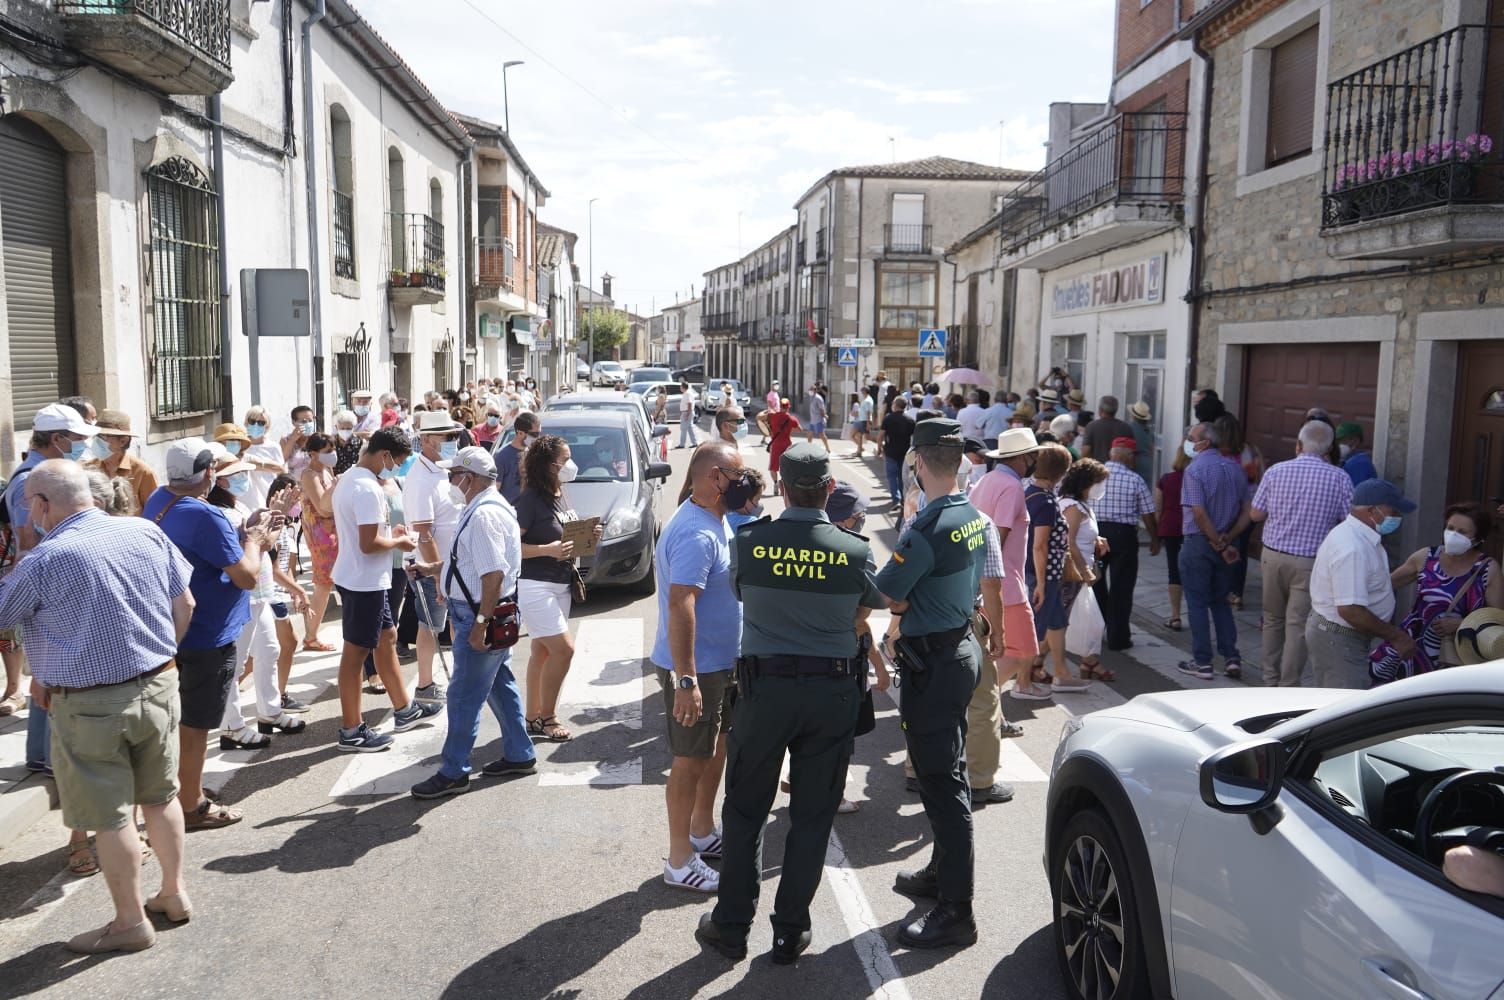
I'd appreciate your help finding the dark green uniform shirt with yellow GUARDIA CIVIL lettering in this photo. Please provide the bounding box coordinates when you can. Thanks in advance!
[731,507,883,659]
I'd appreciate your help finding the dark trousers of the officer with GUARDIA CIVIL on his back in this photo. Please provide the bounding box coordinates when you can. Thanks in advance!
[713,677,862,941]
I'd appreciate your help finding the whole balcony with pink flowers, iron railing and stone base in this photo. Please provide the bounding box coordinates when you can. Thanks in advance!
[1322,24,1504,259]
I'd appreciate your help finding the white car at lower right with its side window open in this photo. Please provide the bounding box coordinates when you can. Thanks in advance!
[1045,662,1504,1000]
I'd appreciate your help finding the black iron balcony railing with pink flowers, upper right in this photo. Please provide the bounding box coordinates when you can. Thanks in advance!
[1322,24,1504,229]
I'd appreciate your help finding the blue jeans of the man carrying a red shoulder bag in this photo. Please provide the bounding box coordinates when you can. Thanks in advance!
[439,602,537,779]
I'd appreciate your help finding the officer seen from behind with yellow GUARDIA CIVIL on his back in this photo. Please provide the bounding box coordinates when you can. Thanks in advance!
[695,444,883,965]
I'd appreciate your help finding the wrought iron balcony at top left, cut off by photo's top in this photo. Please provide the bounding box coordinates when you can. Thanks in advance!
[57,0,235,95]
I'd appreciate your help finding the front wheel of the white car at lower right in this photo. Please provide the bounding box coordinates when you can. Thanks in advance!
[1050,809,1149,1000]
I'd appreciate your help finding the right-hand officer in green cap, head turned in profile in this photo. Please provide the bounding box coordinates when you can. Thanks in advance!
[877,420,987,947]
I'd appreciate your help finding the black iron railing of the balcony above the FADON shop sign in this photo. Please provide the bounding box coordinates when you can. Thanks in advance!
[1000,111,1185,253]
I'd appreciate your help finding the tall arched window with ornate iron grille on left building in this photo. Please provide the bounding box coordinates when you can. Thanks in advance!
[146,156,223,418]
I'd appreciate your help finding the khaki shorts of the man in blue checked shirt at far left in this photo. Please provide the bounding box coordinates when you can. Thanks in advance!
[51,671,180,830]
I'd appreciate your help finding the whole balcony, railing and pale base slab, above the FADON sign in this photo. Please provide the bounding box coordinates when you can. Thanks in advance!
[999,111,1185,265]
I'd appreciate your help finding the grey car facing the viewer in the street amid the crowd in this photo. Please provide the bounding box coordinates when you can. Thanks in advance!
[532,409,671,594]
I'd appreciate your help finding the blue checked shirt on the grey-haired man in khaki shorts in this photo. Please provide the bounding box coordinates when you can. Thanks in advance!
[0,508,193,687]
